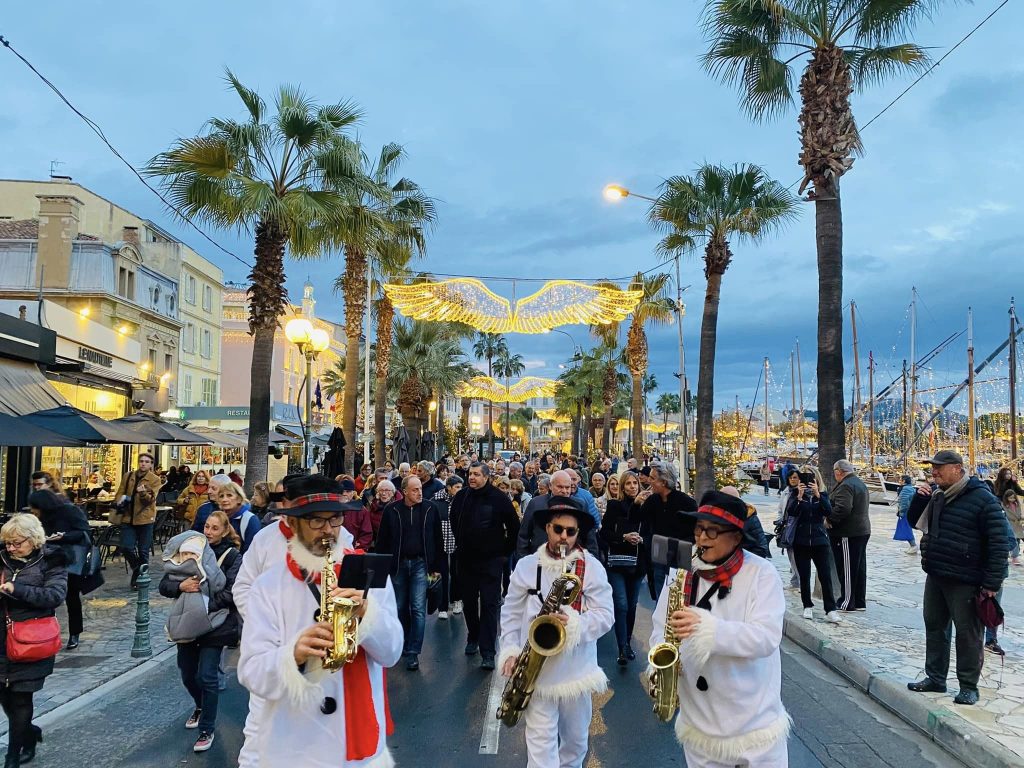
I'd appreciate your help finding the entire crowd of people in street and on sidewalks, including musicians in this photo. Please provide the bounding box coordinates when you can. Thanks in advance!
[0,451,1024,768]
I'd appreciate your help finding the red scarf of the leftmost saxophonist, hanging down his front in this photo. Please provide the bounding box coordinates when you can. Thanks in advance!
[279,520,394,760]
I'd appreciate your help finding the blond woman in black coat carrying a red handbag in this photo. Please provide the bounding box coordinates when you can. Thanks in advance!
[0,514,68,768]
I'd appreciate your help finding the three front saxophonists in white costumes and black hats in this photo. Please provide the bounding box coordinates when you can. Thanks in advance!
[234,475,791,768]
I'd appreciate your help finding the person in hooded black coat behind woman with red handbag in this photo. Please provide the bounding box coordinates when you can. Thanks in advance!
[29,490,92,650]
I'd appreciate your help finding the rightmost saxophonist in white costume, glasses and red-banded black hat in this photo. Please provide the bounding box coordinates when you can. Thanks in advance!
[647,490,791,768]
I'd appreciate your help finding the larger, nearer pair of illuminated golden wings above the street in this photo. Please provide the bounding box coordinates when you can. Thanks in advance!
[384,278,643,334]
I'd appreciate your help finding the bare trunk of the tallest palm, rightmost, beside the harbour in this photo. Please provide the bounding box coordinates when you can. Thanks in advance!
[814,181,846,488]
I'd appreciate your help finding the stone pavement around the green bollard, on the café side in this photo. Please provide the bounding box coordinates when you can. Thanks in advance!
[0,548,172,735]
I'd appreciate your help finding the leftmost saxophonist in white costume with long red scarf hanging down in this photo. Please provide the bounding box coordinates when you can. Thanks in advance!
[239,494,402,768]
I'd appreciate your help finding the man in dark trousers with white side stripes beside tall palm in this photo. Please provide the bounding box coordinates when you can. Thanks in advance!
[828,459,871,611]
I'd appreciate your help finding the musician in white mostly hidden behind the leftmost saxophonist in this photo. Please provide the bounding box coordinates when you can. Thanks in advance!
[231,474,352,768]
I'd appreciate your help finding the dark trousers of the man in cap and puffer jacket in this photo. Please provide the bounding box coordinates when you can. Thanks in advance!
[923,575,985,690]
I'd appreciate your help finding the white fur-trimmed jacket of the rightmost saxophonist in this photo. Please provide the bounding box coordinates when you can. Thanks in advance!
[647,552,791,765]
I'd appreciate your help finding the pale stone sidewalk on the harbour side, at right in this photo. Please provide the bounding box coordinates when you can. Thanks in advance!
[744,492,1024,767]
